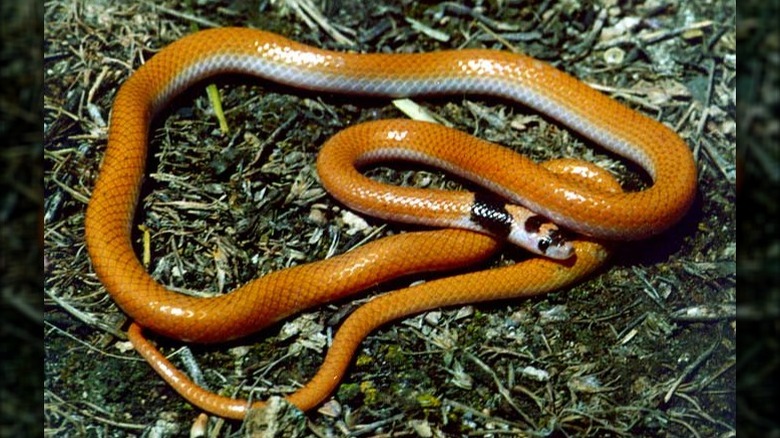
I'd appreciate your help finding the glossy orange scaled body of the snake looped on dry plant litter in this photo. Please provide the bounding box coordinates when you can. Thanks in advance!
[85,28,697,418]
